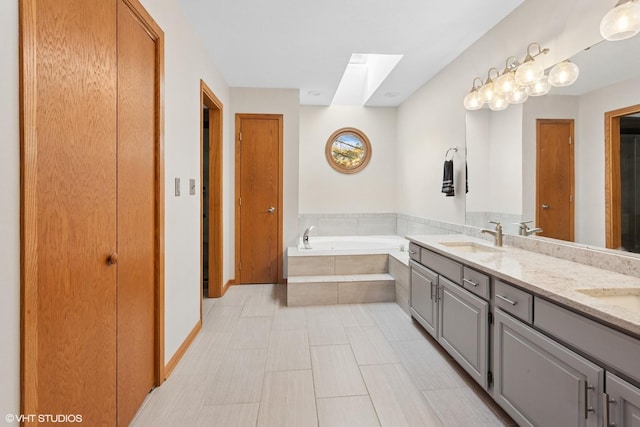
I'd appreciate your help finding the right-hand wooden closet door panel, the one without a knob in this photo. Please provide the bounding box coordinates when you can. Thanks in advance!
[117,0,156,426]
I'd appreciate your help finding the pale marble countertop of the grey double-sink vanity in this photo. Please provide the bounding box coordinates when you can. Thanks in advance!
[406,234,640,337]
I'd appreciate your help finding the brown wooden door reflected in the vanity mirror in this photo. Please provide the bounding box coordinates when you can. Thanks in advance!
[536,119,574,241]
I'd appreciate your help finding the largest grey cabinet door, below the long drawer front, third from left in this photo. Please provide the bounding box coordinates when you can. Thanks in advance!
[493,309,604,427]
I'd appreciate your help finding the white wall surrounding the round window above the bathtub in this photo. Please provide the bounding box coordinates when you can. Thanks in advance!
[300,106,396,214]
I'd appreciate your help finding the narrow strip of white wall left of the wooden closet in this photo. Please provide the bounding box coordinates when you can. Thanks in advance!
[0,0,20,425]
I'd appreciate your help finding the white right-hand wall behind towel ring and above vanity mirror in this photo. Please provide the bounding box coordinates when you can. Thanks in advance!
[397,0,613,223]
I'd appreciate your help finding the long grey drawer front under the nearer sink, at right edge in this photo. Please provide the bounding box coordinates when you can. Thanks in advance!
[534,297,640,382]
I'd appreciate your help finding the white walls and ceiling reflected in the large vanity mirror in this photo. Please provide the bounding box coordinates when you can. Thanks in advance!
[466,37,640,256]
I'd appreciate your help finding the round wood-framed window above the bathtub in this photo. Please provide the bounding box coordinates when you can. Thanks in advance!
[324,128,371,173]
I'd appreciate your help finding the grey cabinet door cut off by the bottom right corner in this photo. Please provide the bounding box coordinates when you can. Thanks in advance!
[607,372,640,427]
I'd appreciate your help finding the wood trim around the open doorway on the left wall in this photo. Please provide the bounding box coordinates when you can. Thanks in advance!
[200,80,224,300]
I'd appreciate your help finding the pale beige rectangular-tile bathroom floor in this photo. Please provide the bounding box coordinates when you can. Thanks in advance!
[132,285,515,427]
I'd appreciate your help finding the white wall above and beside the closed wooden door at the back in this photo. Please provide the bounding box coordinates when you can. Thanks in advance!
[230,88,300,254]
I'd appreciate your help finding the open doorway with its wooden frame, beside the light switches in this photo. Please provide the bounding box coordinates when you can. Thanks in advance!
[200,80,224,298]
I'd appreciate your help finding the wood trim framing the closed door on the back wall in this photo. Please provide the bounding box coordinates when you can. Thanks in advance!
[234,113,284,283]
